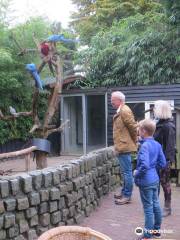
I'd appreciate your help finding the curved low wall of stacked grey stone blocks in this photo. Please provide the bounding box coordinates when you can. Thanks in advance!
[0,148,120,240]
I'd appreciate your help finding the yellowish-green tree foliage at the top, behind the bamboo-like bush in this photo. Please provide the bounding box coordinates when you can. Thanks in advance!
[72,0,162,44]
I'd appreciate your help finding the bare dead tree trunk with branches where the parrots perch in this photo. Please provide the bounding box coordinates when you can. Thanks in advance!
[0,36,68,169]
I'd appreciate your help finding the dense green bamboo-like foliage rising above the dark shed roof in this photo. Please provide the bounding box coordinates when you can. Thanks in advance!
[76,12,180,87]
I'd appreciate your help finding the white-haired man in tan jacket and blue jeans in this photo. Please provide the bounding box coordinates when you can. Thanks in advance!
[111,91,137,205]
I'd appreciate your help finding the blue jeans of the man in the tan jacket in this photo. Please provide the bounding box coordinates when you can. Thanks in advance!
[117,153,133,197]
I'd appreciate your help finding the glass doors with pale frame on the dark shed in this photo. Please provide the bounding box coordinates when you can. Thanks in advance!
[61,94,107,155]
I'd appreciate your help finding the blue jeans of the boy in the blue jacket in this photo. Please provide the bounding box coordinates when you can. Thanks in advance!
[139,183,162,238]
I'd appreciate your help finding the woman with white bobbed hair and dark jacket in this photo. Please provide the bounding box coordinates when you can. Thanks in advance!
[154,100,176,217]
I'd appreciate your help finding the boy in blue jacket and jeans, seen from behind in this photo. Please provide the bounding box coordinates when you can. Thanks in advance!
[134,119,166,239]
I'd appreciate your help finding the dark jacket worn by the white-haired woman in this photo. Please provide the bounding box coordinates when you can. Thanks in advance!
[154,119,176,162]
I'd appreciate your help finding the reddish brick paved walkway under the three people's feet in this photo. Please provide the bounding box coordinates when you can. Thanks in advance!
[81,187,180,240]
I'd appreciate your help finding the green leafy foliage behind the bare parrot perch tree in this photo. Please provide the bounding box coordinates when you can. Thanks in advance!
[0,13,76,144]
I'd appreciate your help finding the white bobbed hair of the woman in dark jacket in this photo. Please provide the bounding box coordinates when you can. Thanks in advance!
[154,100,172,119]
